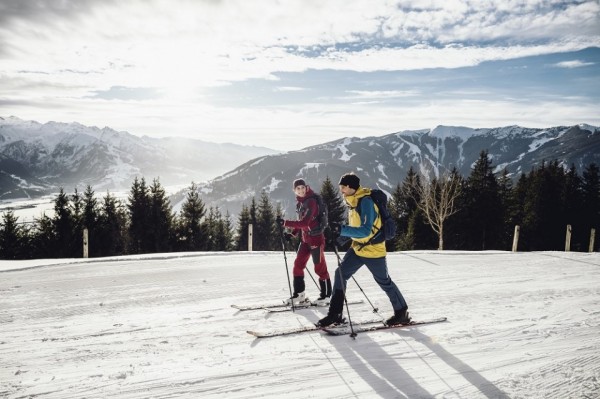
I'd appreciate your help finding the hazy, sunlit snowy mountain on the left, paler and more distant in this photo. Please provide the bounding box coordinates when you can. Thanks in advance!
[0,117,276,199]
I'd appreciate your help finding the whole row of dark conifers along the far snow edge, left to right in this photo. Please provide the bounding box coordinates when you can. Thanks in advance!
[0,151,600,259]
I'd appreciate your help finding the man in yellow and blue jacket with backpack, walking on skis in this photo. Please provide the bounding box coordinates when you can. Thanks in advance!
[317,173,410,327]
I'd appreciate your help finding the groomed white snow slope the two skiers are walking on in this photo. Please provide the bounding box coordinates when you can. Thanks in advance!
[0,251,600,399]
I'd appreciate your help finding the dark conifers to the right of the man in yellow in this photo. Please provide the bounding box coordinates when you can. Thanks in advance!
[389,151,600,251]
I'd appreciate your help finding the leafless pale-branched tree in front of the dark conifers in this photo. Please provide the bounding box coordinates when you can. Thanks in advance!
[414,171,461,251]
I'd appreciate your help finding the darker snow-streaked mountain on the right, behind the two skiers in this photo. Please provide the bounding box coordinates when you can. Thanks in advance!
[202,124,600,219]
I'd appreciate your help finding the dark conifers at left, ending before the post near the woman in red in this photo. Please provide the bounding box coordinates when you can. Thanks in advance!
[0,178,234,259]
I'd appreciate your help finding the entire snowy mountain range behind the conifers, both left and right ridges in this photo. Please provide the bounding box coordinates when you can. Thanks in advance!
[0,117,600,220]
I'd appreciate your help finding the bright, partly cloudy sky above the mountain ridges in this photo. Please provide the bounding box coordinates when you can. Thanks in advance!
[0,0,600,151]
